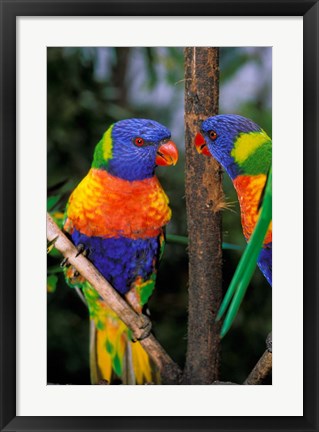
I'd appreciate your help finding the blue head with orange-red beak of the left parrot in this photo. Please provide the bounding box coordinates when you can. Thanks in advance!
[92,119,178,181]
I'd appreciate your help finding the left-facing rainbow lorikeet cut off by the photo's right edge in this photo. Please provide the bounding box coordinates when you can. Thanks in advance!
[195,114,272,285]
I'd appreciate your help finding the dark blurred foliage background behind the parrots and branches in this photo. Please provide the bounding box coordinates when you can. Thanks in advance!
[47,47,272,384]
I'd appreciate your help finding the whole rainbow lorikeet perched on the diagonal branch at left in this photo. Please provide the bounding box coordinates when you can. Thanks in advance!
[64,119,178,384]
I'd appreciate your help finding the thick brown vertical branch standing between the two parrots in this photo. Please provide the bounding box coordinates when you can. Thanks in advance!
[184,47,223,384]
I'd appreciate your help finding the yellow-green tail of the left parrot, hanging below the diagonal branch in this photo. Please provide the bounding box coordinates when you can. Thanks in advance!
[83,287,159,384]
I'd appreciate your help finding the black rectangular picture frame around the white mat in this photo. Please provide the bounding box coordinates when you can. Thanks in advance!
[0,0,319,431]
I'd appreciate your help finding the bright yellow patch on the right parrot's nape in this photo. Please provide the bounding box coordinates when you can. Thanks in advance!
[231,130,270,164]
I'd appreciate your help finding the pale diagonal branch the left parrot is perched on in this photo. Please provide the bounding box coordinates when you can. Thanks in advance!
[47,214,181,384]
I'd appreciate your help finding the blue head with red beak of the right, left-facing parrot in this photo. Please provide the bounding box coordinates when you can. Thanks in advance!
[195,114,269,179]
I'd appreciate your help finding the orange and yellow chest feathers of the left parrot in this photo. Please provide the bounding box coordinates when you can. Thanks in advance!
[64,169,171,239]
